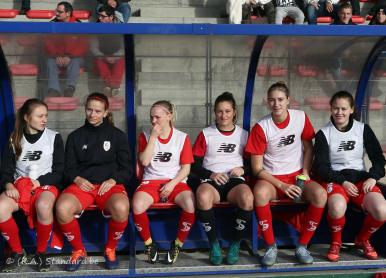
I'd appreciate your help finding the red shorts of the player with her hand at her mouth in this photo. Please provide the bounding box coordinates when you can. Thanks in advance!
[135,180,192,203]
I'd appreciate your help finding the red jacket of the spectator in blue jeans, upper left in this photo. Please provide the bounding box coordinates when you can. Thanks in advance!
[44,17,89,57]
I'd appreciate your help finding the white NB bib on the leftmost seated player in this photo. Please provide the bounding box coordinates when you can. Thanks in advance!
[14,128,57,180]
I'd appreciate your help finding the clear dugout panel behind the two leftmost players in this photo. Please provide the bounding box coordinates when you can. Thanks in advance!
[2,34,126,139]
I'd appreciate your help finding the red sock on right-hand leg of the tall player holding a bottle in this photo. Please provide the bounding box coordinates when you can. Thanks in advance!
[299,204,324,245]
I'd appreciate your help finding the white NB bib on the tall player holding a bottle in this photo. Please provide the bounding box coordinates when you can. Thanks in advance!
[258,109,306,175]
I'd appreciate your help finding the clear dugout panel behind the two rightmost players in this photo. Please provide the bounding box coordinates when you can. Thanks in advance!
[251,37,378,131]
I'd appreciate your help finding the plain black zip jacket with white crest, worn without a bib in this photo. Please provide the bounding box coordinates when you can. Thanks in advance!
[64,119,134,186]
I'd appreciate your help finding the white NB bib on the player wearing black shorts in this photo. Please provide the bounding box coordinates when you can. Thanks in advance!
[202,125,248,173]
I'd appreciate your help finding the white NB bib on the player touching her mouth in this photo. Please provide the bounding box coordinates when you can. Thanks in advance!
[143,128,187,182]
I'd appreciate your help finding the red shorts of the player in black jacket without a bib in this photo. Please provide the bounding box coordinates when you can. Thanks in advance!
[63,184,127,211]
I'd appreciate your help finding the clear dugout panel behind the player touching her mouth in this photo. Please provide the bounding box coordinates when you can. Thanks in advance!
[135,35,207,141]
